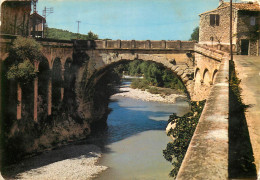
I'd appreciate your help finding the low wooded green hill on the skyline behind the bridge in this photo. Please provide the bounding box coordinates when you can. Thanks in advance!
[46,28,98,40]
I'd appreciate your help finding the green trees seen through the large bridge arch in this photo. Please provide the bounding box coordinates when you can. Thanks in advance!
[121,60,186,92]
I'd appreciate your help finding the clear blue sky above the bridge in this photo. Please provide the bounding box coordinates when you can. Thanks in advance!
[37,0,242,40]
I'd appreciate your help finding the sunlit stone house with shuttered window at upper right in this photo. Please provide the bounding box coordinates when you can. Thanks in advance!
[199,1,260,56]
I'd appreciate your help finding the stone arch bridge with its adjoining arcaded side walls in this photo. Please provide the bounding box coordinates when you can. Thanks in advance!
[1,35,228,121]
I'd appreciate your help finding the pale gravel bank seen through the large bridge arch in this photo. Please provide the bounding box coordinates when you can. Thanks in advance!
[113,86,186,103]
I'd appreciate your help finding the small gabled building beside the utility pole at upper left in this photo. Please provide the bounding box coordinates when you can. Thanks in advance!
[30,12,46,38]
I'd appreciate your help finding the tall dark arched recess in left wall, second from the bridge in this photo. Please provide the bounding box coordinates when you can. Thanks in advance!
[51,58,62,111]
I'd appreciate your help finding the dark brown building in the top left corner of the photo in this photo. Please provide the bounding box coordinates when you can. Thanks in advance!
[1,0,31,36]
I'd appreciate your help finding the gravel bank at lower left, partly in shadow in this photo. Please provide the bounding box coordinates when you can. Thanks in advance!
[4,145,107,180]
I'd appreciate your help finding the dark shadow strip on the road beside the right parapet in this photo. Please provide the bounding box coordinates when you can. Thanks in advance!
[228,61,256,179]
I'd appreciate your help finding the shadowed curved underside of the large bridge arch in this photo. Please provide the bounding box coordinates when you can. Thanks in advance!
[78,59,190,126]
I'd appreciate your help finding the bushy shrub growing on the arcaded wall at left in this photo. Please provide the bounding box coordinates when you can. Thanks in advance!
[7,37,42,84]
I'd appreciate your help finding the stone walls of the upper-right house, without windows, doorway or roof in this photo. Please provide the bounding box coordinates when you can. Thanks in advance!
[199,6,260,56]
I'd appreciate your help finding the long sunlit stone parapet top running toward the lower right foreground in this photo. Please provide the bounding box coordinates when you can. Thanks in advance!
[177,58,229,180]
